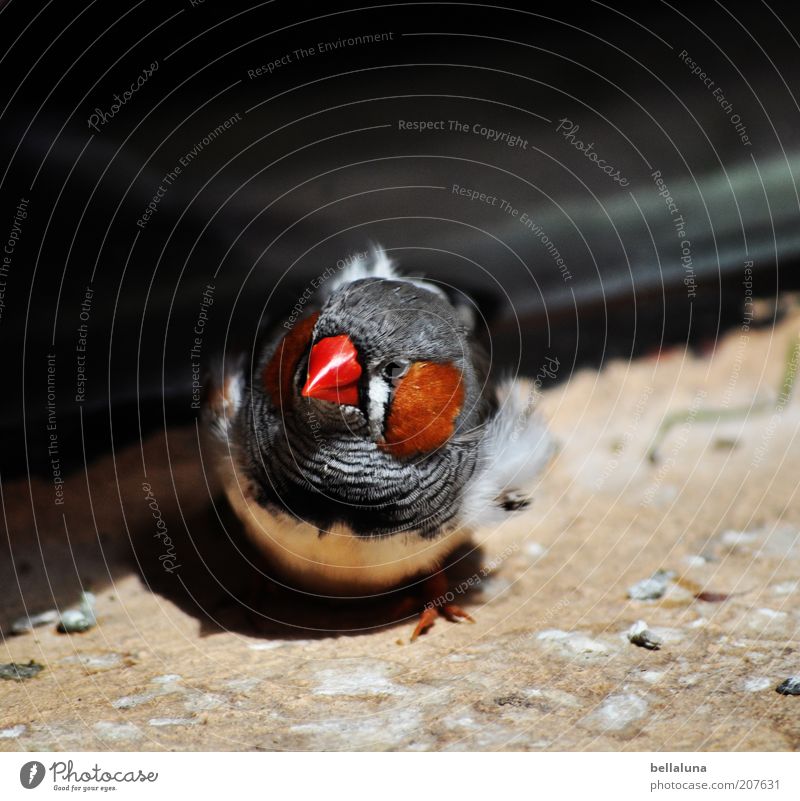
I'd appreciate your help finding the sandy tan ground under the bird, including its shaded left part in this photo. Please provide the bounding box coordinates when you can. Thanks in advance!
[0,308,800,750]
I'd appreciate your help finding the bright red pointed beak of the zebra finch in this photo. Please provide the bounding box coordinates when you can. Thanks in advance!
[300,334,361,406]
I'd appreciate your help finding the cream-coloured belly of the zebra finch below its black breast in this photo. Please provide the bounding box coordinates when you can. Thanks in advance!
[216,458,471,596]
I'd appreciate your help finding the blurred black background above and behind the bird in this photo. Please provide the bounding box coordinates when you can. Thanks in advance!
[0,0,800,480]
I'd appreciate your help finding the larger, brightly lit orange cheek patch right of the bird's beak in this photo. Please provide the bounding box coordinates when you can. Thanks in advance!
[382,362,464,458]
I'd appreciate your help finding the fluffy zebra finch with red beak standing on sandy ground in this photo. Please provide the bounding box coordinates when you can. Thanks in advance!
[203,247,554,640]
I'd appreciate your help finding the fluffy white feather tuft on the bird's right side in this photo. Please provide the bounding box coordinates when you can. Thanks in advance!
[459,380,554,528]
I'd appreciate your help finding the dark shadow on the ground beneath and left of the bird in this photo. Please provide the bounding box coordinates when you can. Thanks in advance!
[0,428,481,639]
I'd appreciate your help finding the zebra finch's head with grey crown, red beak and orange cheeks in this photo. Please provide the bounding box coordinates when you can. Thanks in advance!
[264,279,473,459]
